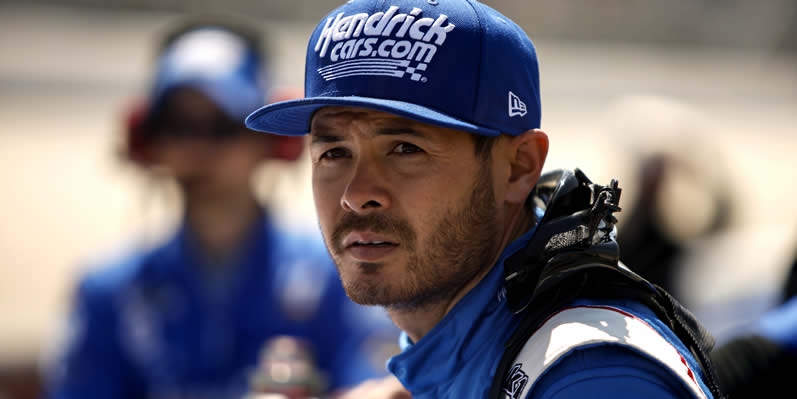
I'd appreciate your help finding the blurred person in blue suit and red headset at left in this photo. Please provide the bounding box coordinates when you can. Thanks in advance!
[42,20,397,399]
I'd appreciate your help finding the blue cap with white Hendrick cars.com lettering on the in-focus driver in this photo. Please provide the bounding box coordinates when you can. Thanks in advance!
[246,0,540,136]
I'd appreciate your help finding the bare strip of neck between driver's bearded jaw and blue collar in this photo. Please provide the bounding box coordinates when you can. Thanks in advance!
[387,205,534,342]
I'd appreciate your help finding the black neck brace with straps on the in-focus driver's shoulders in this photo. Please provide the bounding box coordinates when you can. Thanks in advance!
[490,169,723,399]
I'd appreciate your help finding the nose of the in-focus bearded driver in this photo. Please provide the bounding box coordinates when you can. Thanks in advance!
[340,159,392,213]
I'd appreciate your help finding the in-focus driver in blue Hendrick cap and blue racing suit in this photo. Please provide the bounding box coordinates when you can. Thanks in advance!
[247,0,717,398]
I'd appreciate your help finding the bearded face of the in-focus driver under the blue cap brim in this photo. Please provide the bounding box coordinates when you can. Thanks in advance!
[310,107,499,309]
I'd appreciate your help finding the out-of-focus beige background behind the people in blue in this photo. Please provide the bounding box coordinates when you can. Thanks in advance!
[0,0,797,399]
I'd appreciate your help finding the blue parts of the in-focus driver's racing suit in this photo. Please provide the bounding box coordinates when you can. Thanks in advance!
[388,230,712,399]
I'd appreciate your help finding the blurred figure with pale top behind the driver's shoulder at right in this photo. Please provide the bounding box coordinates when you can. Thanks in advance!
[604,94,732,300]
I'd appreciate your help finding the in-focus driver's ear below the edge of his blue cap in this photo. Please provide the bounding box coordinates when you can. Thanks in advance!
[505,129,548,204]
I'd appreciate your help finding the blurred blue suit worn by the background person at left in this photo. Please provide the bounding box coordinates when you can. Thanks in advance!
[48,217,398,399]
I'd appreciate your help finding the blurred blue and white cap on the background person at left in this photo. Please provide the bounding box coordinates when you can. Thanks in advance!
[150,25,265,122]
